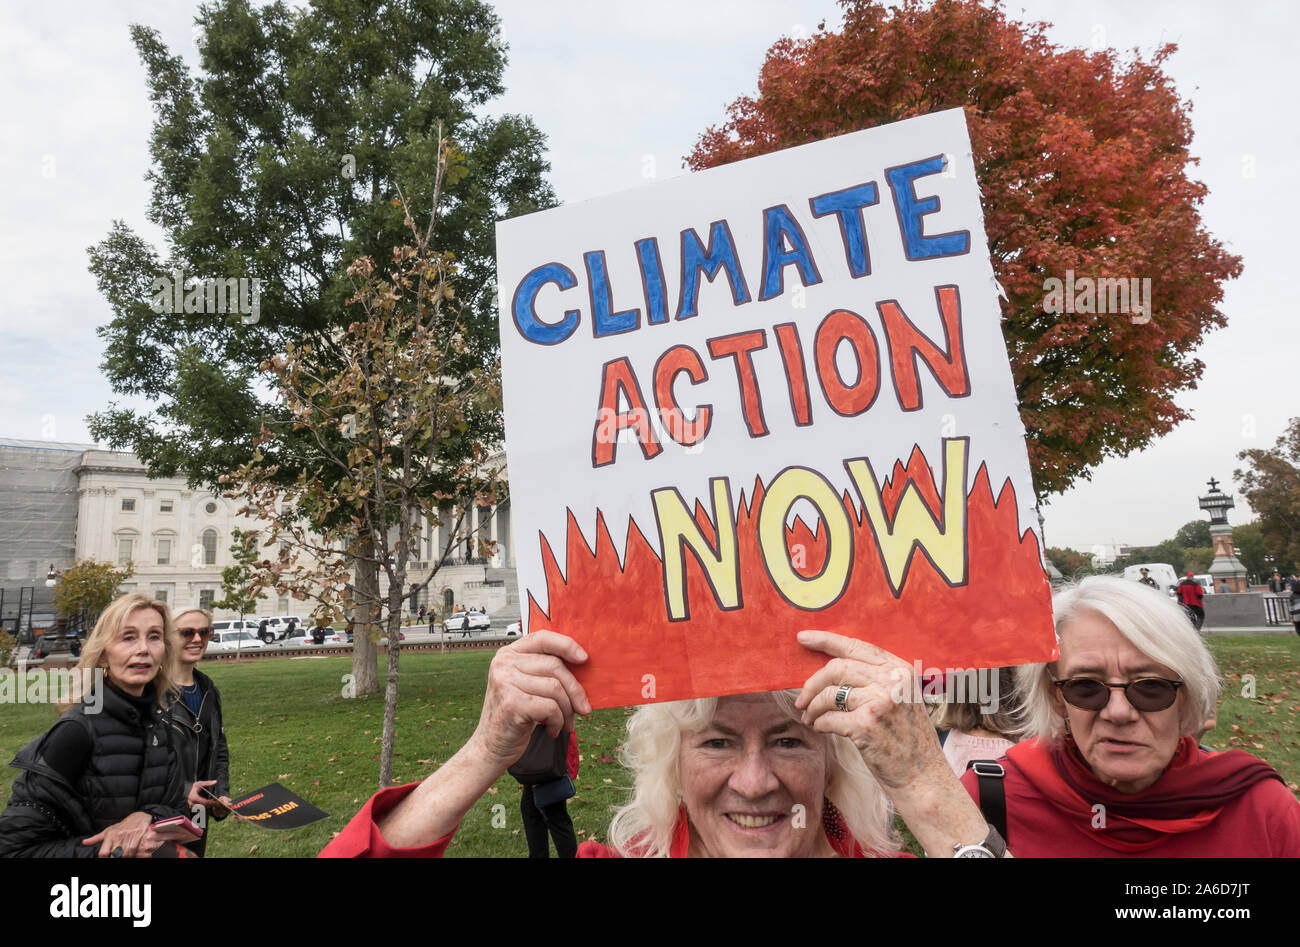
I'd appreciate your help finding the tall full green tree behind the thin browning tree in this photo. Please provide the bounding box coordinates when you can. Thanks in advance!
[90,0,554,693]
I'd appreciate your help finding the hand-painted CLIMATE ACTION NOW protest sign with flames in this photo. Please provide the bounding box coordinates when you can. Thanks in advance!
[497,111,1054,706]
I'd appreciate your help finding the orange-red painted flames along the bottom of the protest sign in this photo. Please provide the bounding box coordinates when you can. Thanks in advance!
[528,450,1056,708]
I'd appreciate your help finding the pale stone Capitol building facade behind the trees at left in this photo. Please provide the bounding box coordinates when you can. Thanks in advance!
[0,438,519,619]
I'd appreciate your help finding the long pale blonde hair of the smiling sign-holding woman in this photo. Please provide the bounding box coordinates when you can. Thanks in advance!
[610,691,901,859]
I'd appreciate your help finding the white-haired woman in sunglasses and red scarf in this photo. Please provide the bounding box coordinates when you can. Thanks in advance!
[962,576,1300,857]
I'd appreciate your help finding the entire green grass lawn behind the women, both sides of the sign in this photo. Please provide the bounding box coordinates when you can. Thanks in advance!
[0,636,1300,857]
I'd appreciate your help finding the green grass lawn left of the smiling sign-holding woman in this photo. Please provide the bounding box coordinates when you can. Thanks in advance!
[0,650,639,857]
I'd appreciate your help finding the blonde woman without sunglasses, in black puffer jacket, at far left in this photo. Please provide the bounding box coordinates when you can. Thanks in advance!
[0,593,186,859]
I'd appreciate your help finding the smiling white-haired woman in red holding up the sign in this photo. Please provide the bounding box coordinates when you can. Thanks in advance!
[321,631,1005,857]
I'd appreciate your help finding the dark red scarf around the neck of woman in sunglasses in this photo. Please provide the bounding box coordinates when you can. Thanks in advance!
[1006,735,1282,853]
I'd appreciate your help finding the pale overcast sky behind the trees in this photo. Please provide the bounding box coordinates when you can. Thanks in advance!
[0,0,1300,550]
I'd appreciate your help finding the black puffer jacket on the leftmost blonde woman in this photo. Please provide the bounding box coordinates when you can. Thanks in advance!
[0,684,189,859]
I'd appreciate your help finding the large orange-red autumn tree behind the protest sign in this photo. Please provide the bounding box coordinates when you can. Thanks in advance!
[686,0,1242,496]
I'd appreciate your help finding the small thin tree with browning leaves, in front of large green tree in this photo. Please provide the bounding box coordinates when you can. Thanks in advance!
[222,144,504,787]
